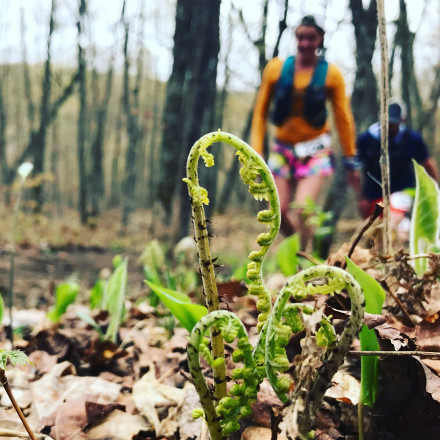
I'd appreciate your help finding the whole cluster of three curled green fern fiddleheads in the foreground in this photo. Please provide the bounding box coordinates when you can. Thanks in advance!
[184,131,364,440]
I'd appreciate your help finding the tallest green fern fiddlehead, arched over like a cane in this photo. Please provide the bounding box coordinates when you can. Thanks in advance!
[184,130,281,400]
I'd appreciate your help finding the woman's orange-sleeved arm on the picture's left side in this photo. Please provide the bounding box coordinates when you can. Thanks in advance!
[250,58,281,155]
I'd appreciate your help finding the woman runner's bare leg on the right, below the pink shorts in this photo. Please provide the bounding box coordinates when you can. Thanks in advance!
[293,176,326,251]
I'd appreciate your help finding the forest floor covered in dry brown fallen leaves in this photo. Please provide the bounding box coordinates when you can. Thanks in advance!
[0,208,440,440]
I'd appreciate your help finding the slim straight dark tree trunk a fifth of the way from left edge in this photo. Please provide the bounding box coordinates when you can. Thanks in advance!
[76,0,88,224]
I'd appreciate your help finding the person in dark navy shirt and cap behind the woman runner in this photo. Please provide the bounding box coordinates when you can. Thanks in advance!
[357,100,438,237]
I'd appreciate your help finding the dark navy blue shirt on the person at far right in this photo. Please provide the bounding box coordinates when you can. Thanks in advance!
[357,122,429,200]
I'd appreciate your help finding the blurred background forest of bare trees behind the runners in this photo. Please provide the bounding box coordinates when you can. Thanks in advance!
[0,0,440,248]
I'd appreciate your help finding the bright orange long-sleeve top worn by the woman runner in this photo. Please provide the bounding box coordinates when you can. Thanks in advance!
[251,57,356,156]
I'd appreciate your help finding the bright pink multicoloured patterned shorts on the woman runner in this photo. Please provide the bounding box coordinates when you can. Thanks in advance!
[267,141,334,180]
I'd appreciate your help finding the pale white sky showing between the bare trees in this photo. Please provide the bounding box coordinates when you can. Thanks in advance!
[0,0,440,89]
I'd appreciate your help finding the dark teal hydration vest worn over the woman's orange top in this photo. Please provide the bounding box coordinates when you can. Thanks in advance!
[270,56,328,128]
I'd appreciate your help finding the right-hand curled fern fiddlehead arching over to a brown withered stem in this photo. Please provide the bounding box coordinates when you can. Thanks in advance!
[265,265,365,436]
